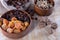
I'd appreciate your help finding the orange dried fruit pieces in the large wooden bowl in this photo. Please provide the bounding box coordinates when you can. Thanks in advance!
[0,17,29,33]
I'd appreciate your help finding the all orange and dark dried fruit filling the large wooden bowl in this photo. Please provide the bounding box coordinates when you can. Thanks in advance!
[2,10,30,33]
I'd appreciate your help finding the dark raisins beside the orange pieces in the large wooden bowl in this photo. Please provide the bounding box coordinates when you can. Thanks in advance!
[1,10,30,23]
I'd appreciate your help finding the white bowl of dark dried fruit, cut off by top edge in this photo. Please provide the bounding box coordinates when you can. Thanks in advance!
[0,0,30,10]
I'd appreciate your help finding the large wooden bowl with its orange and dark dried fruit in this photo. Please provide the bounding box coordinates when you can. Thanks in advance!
[0,10,33,38]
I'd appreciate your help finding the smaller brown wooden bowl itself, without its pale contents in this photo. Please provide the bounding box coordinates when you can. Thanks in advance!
[34,0,54,16]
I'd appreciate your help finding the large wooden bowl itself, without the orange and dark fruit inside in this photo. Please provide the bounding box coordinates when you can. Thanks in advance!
[0,10,34,39]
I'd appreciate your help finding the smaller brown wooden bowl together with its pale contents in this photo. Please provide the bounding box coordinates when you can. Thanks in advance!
[34,0,54,16]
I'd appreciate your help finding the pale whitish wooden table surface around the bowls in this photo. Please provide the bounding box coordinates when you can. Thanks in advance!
[0,0,60,40]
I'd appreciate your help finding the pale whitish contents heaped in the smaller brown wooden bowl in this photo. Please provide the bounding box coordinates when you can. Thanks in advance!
[36,0,53,9]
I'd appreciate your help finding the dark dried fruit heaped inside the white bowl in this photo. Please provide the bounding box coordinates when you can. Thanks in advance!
[6,0,29,8]
